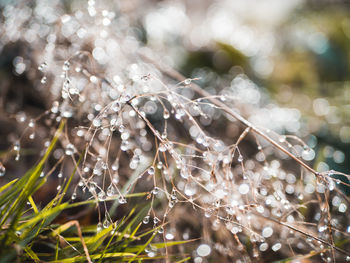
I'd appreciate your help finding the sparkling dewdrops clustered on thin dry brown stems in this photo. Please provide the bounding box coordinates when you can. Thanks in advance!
[0,0,350,262]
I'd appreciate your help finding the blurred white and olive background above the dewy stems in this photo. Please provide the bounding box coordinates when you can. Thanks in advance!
[138,0,350,175]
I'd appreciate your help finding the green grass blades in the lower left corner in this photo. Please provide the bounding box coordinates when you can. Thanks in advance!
[0,121,190,263]
